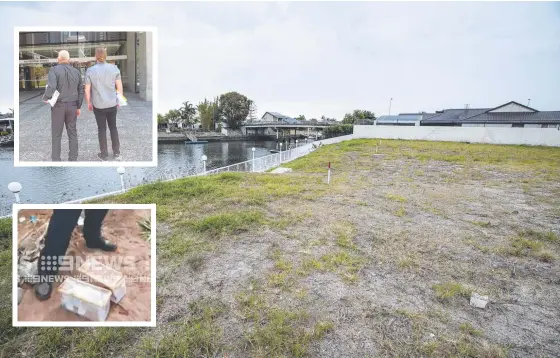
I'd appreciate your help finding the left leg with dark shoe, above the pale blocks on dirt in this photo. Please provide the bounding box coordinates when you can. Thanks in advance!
[35,209,82,300]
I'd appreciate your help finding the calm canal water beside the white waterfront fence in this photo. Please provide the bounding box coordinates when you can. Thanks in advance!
[0,141,276,215]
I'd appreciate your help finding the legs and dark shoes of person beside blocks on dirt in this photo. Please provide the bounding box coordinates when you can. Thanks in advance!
[34,209,117,301]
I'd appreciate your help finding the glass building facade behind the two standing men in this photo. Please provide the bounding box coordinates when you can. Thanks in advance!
[19,31,132,92]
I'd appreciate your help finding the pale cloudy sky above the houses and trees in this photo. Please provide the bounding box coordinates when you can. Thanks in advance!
[0,1,560,119]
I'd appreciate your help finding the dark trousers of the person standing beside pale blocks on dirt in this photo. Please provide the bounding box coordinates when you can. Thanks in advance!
[39,209,109,276]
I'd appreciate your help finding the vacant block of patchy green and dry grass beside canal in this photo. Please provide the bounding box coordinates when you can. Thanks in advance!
[0,140,560,357]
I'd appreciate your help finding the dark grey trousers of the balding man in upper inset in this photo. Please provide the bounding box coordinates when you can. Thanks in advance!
[51,102,78,162]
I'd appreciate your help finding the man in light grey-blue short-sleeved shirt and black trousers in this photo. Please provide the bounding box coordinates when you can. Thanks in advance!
[86,48,123,161]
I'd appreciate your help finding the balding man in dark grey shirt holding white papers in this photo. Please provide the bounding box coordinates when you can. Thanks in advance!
[43,50,84,162]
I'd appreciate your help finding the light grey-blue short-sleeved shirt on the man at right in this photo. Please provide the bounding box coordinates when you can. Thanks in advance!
[86,62,121,109]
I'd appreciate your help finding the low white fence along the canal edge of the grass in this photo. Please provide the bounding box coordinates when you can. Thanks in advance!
[0,135,353,219]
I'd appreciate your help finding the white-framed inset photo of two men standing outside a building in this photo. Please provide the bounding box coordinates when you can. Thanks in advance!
[14,26,158,167]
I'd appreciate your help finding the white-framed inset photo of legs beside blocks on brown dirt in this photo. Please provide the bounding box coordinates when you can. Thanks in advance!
[12,204,156,327]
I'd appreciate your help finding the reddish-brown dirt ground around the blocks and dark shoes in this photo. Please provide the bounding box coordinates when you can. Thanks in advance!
[18,209,151,322]
